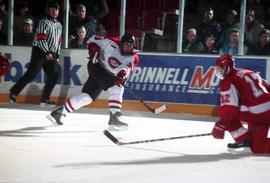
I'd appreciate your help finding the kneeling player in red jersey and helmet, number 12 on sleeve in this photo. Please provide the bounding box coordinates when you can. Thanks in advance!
[211,54,270,153]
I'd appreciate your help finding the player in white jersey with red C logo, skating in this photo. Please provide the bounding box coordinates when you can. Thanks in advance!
[48,33,139,129]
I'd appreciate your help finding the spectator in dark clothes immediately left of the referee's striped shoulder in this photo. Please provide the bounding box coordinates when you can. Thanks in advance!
[14,18,34,46]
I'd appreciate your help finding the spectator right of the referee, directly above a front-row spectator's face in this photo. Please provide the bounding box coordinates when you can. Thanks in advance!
[69,4,89,40]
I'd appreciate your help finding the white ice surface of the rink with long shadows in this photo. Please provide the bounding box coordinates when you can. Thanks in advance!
[0,104,270,183]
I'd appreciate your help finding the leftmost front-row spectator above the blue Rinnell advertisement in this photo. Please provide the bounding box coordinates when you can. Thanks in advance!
[182,29,203,53]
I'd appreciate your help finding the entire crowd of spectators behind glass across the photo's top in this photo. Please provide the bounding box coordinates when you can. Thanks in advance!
[0,0,270,55]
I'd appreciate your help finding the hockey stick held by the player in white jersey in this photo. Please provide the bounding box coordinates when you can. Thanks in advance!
[92,52,166,114]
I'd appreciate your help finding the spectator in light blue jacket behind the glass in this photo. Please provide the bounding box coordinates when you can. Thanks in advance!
[219,29,239,55]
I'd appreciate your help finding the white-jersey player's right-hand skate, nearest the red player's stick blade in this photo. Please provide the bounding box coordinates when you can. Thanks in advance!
[108,112,128,131]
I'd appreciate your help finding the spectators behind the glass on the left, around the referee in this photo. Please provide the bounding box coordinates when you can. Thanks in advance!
[0,0,109,48]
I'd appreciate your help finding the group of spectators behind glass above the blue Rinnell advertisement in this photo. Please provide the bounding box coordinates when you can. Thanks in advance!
[183,5,270,55]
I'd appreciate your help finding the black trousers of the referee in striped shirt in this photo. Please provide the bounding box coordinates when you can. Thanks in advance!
[10,47,58,101]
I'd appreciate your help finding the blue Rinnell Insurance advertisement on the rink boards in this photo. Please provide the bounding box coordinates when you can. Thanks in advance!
[124,55,266,105]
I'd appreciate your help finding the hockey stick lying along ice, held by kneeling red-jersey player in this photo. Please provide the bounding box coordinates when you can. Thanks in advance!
[103,130,211,145]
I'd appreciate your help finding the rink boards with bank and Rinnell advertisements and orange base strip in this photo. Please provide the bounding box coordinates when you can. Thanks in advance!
[0,46,270,115]
